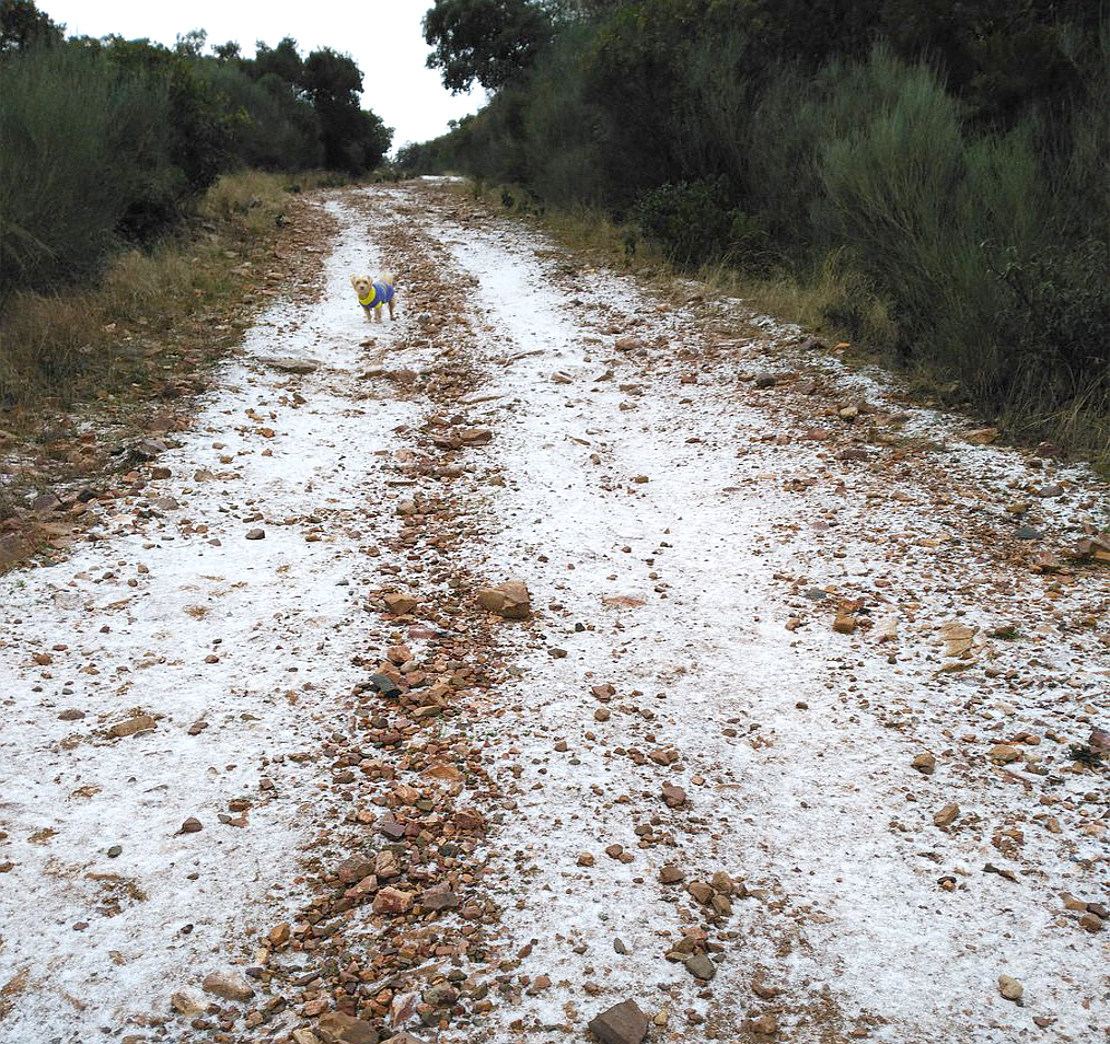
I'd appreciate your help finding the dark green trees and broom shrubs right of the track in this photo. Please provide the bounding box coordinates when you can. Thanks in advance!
[408,0,1110,450]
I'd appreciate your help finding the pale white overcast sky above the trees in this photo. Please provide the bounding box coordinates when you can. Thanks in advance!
[43,0,485,148]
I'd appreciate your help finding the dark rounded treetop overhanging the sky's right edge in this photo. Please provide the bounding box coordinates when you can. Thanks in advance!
[424,0,553,94]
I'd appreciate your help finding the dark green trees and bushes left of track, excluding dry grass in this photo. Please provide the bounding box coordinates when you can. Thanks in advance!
[0,0,392,303]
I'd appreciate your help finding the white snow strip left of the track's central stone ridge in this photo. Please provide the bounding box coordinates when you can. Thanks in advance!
[0,204,412,1042]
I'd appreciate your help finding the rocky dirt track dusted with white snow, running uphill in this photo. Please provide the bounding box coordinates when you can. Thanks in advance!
[0,183,1110,1044]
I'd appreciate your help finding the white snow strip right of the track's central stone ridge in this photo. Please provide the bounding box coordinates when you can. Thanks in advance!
[415,197,1110,1042]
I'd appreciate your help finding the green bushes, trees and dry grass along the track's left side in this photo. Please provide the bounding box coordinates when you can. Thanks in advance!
[0,0,392,419]
